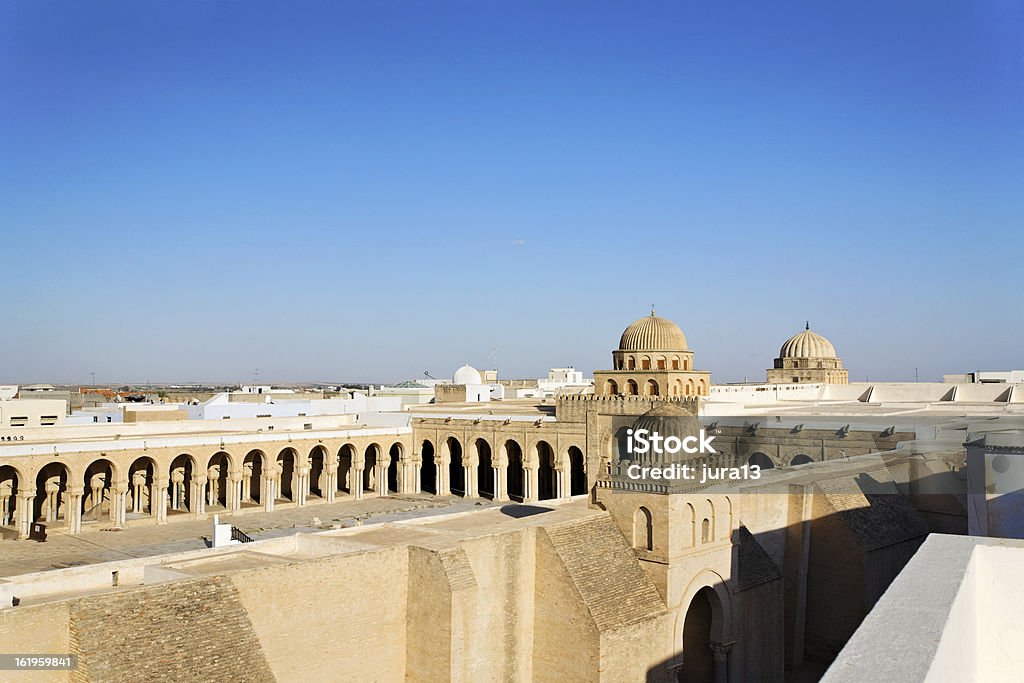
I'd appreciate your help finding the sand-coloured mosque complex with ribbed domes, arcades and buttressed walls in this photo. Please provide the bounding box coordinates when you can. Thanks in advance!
[0,310,1024,683]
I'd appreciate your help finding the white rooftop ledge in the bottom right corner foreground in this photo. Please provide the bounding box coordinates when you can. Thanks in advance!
[821,533,1024,683]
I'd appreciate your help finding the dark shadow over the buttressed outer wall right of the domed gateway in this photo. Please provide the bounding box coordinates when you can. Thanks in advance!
[645,454,968,683]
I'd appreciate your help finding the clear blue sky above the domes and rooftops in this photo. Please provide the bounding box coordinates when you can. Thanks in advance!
[0,0,1024,382]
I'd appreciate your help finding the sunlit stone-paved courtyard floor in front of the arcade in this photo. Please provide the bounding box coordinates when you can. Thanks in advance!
[0,494,495,578]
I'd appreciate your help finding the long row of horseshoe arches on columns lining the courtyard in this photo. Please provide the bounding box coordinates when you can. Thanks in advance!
[0,433,588,538]
